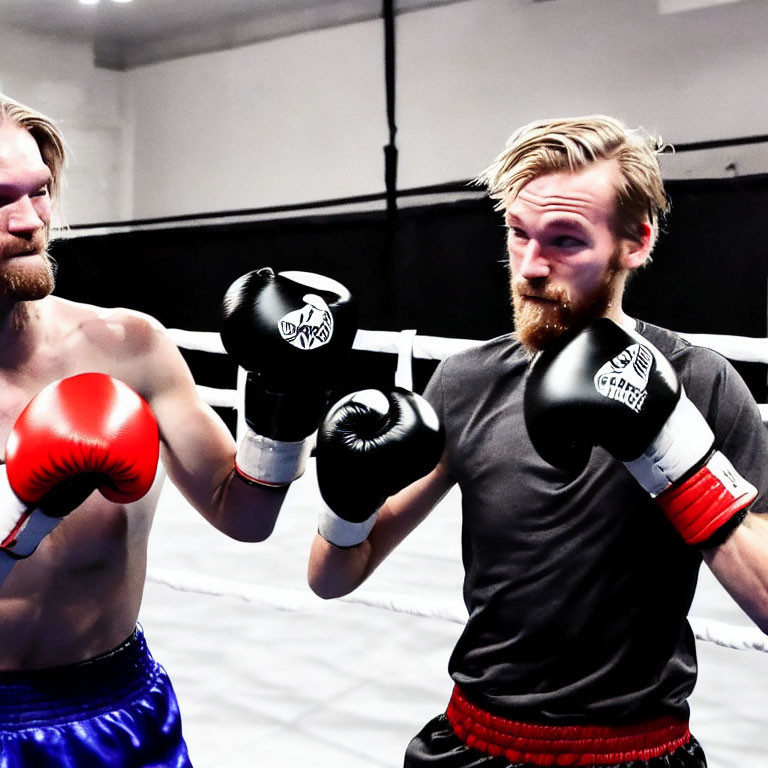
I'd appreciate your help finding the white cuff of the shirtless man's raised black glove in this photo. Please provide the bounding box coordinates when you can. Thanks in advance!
[235,429,314,486]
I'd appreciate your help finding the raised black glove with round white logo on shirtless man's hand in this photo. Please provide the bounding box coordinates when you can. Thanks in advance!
[220,267,357,486]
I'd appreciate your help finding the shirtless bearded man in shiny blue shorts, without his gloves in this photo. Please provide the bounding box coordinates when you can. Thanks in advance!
[0,95,349,768]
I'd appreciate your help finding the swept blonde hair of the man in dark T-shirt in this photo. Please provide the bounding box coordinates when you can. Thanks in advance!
[475,115,669,245]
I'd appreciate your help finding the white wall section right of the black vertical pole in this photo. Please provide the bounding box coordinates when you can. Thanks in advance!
[398,0,768,187]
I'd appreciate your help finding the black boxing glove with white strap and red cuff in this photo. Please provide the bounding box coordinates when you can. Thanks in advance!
[524,318,757,544]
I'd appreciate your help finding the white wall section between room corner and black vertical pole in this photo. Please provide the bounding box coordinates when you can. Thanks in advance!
[127,24,387,218]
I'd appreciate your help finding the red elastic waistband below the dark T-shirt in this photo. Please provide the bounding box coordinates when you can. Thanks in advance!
[446,686,691,766]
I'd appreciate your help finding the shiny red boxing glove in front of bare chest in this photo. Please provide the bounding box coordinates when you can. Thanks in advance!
[5,373,160,515]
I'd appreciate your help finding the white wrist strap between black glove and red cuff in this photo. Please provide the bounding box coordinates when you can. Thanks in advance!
[625,392,715,498]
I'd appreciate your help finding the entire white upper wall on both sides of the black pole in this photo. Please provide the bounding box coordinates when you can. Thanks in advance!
[0,0,768,223]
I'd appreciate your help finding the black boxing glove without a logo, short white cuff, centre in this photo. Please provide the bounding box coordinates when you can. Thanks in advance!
[316,387,445,547]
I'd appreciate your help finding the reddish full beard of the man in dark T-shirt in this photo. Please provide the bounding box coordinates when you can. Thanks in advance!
[511,257,620,352]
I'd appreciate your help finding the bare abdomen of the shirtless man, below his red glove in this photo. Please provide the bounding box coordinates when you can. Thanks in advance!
[0,484,164,669]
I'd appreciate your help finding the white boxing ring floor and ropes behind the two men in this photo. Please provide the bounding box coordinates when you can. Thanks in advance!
[140,329,768,768]
